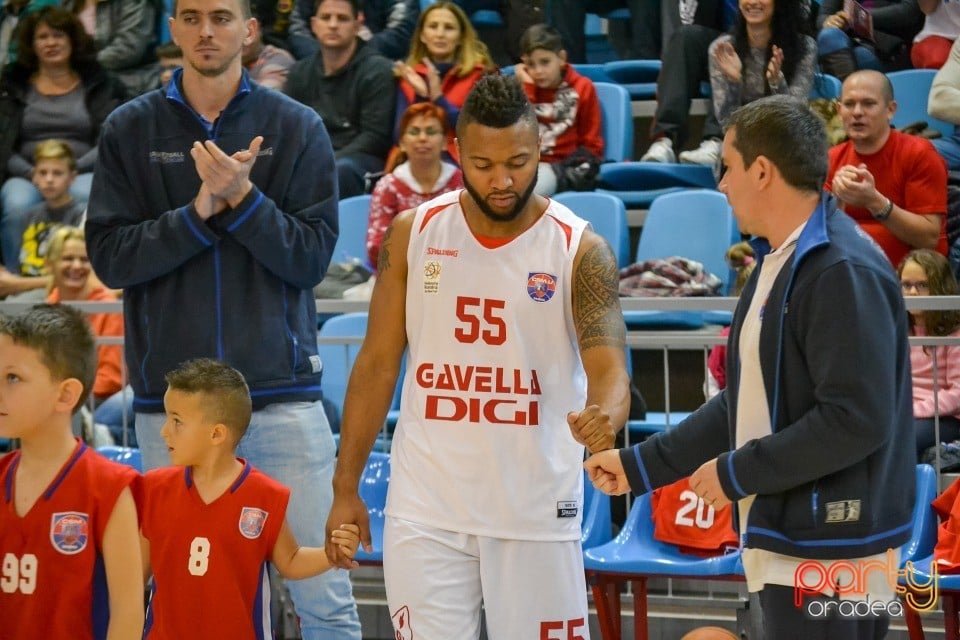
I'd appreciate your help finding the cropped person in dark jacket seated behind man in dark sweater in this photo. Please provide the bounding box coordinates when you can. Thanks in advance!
[288,0,420,60]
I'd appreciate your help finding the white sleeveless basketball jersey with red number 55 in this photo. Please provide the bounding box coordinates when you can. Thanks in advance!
[386,191,587,540]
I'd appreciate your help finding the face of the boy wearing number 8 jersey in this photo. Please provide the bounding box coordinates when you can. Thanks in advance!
[160,389,215,466]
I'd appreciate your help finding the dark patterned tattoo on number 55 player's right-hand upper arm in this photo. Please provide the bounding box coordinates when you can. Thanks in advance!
[573,242,627,350]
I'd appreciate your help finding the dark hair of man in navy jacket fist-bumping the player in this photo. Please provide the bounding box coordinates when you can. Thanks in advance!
[727,95,830,193]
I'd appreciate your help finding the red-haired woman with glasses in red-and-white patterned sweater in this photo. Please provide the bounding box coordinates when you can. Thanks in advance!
[367,102,463,267]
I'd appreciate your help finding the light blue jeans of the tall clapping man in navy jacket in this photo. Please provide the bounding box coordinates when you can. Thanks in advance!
[136,400,360,640]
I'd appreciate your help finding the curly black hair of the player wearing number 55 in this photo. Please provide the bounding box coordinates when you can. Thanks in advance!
[457,74,537,136]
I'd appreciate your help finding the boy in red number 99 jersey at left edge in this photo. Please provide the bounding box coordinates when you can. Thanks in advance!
[0,304,143,640]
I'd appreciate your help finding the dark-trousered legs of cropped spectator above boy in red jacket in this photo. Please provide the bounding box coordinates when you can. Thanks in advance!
[548,0,660,64]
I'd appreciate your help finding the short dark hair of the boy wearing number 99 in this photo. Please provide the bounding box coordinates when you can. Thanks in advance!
[0,303,97,413]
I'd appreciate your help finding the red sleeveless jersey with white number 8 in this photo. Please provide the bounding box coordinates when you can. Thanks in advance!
[140,460,288,640]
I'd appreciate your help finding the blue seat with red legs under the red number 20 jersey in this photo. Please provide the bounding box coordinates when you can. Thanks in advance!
[583,493,743,640]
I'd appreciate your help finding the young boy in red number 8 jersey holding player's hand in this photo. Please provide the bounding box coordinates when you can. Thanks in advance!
[140,358,360,640]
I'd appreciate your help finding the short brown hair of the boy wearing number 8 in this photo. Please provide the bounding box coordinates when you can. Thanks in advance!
[164,358,253,443]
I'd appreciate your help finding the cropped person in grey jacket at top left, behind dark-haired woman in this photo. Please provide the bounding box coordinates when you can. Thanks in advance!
[63,0,159,96]
